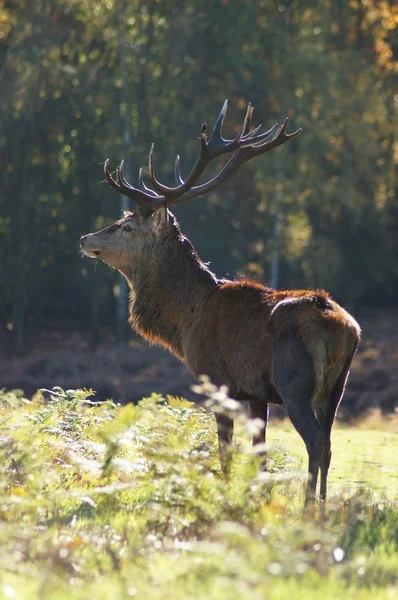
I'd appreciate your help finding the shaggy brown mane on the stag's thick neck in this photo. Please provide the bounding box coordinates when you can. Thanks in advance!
[128,224,219,359]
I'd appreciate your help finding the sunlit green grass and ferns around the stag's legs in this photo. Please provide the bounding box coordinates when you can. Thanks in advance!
[0,389,398,600]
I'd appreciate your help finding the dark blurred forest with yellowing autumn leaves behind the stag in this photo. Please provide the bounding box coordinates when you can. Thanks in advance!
[0,0,398,408]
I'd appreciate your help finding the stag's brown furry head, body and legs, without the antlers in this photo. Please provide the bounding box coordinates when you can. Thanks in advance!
[82,210,360,499]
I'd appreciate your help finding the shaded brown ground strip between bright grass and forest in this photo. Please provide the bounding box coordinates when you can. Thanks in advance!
[0,310,398,419]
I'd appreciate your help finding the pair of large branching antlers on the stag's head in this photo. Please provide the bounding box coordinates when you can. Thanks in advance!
[104,100,301,212]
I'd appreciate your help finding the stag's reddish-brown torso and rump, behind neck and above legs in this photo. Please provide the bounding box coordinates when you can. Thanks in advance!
[173,281,359,411]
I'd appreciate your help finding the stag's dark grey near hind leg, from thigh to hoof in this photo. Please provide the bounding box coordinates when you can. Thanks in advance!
[273,334,325,506]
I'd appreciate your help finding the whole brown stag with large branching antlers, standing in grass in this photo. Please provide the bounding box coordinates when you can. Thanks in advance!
[80,100,361,505]
